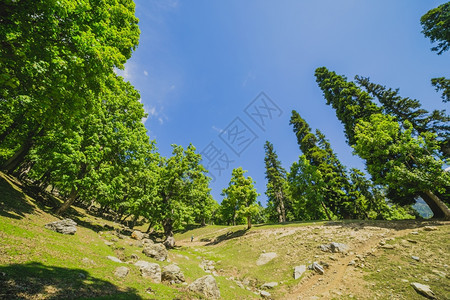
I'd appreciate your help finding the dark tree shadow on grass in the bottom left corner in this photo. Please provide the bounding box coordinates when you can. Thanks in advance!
[0,262,142,299]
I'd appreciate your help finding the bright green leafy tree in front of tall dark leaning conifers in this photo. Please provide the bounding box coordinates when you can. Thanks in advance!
[353,114,450,204]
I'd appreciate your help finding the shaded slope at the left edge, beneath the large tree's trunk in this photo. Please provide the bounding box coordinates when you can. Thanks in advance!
[0,172,35,219]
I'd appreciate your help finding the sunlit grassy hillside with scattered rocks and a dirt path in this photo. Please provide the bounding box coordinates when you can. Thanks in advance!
[0,173,450,299]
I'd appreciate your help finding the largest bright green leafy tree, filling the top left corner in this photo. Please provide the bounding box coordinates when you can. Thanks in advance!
[0,0,139,172]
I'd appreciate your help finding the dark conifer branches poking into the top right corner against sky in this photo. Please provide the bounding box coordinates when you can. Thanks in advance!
[420,2,450,55]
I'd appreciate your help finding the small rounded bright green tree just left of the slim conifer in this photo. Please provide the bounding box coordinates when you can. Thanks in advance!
[221,167,259,229]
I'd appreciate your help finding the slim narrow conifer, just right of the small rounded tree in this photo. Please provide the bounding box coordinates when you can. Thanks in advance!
[264,141,290,223]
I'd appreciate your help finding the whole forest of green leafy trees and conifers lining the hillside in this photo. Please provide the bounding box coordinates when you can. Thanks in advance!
[0,0,450,238]
